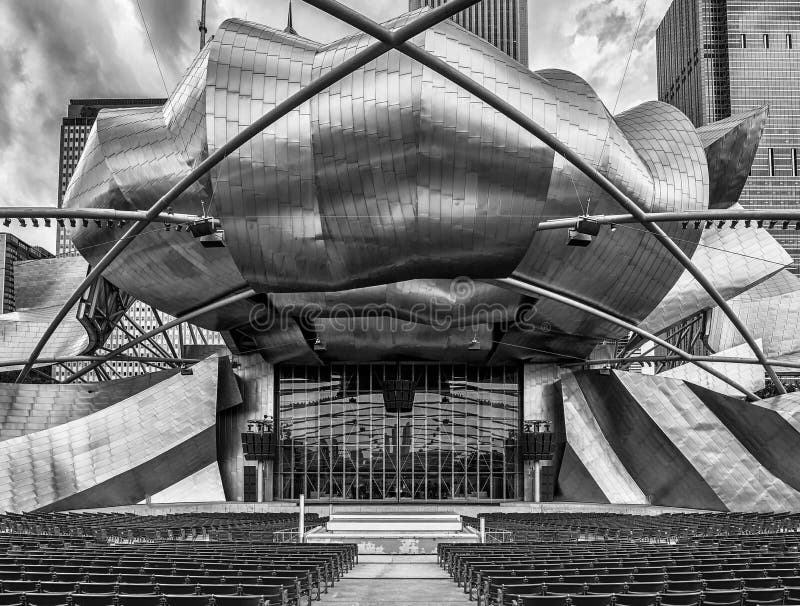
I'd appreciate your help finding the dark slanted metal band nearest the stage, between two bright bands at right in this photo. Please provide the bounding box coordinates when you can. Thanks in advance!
[574,371,727,511]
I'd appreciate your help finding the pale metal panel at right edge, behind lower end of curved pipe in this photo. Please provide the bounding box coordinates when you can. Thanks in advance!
[708,270,800,372]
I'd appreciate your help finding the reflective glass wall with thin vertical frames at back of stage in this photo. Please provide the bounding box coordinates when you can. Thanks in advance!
[277,363,520,501]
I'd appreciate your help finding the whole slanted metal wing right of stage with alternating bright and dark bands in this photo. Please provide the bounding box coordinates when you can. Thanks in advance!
[562,371,800,511]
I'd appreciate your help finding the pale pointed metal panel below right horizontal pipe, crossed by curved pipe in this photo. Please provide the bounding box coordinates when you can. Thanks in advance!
[639,213,792,344]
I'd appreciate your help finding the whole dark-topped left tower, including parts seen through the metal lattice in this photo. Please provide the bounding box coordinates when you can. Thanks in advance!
[54,98,222,379]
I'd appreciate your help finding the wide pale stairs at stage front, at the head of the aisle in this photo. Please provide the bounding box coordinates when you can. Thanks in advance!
[305,511,479,554]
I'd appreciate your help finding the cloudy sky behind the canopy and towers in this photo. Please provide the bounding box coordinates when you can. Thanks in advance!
[0,0,670,250]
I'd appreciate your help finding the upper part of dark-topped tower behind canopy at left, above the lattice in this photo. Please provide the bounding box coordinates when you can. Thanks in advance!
[56,99,166,257]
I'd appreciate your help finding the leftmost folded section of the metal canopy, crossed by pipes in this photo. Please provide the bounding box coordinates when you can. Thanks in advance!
[64,48,247,329]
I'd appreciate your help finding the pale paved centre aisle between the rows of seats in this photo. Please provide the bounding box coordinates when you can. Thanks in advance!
[317,555,474,606]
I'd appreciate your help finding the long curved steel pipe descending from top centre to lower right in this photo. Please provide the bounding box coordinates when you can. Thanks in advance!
[305,0,786,393]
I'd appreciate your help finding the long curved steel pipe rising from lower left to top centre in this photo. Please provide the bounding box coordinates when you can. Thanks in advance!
[16,0,480,383]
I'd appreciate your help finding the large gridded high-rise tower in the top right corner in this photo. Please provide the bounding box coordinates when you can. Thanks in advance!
[656,0,800,274]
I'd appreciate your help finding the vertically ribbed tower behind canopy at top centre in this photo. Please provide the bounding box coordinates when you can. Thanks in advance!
[408,0,528,65]
